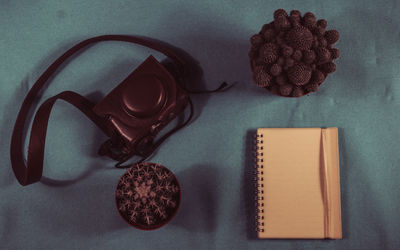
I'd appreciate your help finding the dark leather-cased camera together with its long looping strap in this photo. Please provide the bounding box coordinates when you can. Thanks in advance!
[10,35,197,186]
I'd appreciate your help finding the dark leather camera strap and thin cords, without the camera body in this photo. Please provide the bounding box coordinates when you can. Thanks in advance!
[10,35,216,186]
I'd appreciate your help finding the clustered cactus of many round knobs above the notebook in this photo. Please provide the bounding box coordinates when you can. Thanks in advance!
[249,9,340,97]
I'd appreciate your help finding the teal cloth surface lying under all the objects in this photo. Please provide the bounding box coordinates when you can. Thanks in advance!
[0,0,400,249]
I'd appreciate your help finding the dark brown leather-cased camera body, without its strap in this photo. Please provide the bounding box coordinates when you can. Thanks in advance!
[93,56,189,161]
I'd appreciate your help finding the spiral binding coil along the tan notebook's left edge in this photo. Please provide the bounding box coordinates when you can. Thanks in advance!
[254,134,264,232]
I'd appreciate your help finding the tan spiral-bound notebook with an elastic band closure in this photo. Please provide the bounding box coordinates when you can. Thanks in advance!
[255,128,342,239]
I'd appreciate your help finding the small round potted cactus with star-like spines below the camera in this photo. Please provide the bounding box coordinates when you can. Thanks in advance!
[115,162,180,229]
